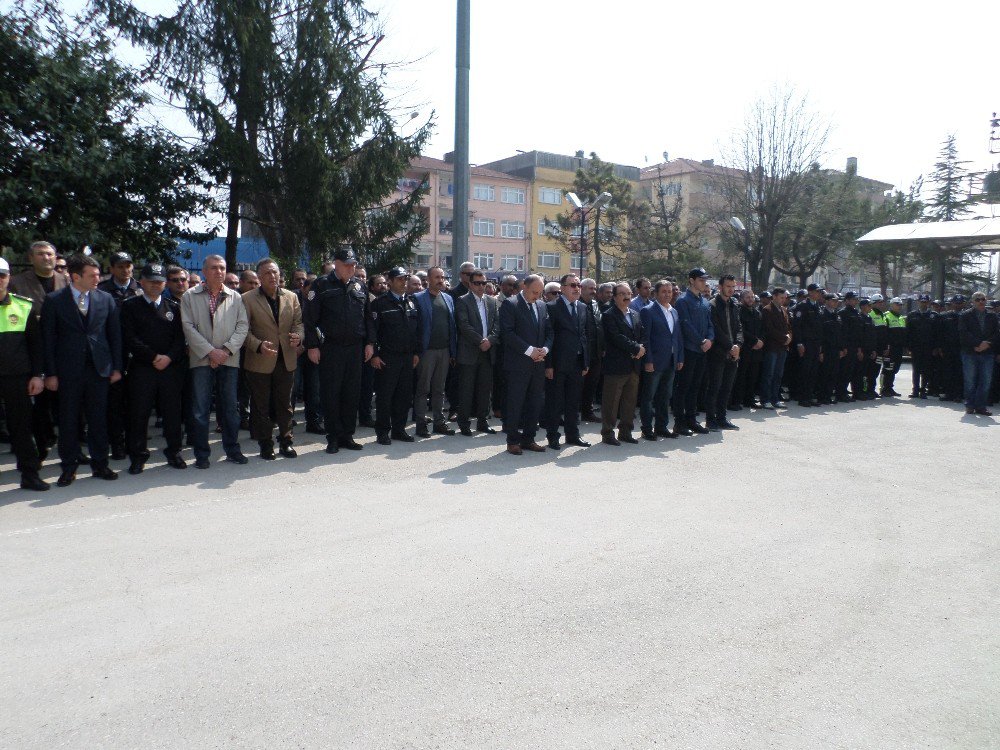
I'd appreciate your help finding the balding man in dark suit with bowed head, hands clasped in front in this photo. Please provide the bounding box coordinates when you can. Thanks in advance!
[500,274,553,456]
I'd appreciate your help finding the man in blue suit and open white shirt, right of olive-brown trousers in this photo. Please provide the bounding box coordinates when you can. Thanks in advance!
[639,280,684,441]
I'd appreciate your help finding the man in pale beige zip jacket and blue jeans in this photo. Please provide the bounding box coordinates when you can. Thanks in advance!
[181,255,248,469]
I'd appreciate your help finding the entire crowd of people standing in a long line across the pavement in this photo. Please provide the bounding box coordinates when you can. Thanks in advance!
[0,242,1000,491]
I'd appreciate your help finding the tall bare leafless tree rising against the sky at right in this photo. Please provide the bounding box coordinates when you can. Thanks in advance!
[717,89,830,289]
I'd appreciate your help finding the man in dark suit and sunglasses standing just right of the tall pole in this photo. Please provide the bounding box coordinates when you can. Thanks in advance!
[455,270,500,436]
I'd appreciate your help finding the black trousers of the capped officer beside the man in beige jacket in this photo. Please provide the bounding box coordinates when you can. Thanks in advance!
[125,363,187,461]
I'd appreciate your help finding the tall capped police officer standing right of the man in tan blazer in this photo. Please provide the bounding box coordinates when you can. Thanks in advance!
[303,248,375,453]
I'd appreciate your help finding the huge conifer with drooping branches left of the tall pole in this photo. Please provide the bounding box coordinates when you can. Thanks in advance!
[93,0,430,274]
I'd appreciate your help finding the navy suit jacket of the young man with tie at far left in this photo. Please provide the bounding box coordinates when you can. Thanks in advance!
[42,287,122,380]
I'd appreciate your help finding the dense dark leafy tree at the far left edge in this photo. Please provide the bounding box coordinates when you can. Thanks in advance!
[0,5,211,258]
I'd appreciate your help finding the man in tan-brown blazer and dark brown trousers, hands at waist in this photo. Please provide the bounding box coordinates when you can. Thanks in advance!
[243,258,305,461]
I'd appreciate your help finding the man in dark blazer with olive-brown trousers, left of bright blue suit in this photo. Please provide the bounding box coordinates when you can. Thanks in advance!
[601,284,646,445]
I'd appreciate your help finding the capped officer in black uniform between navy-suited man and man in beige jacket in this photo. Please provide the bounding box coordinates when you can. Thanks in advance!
[121,263,187,474]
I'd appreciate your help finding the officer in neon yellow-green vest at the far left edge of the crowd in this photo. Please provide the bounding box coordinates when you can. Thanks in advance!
[0,258,49,491]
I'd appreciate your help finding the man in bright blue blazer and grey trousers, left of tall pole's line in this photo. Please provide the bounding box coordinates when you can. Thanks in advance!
[413,266,458,437]
